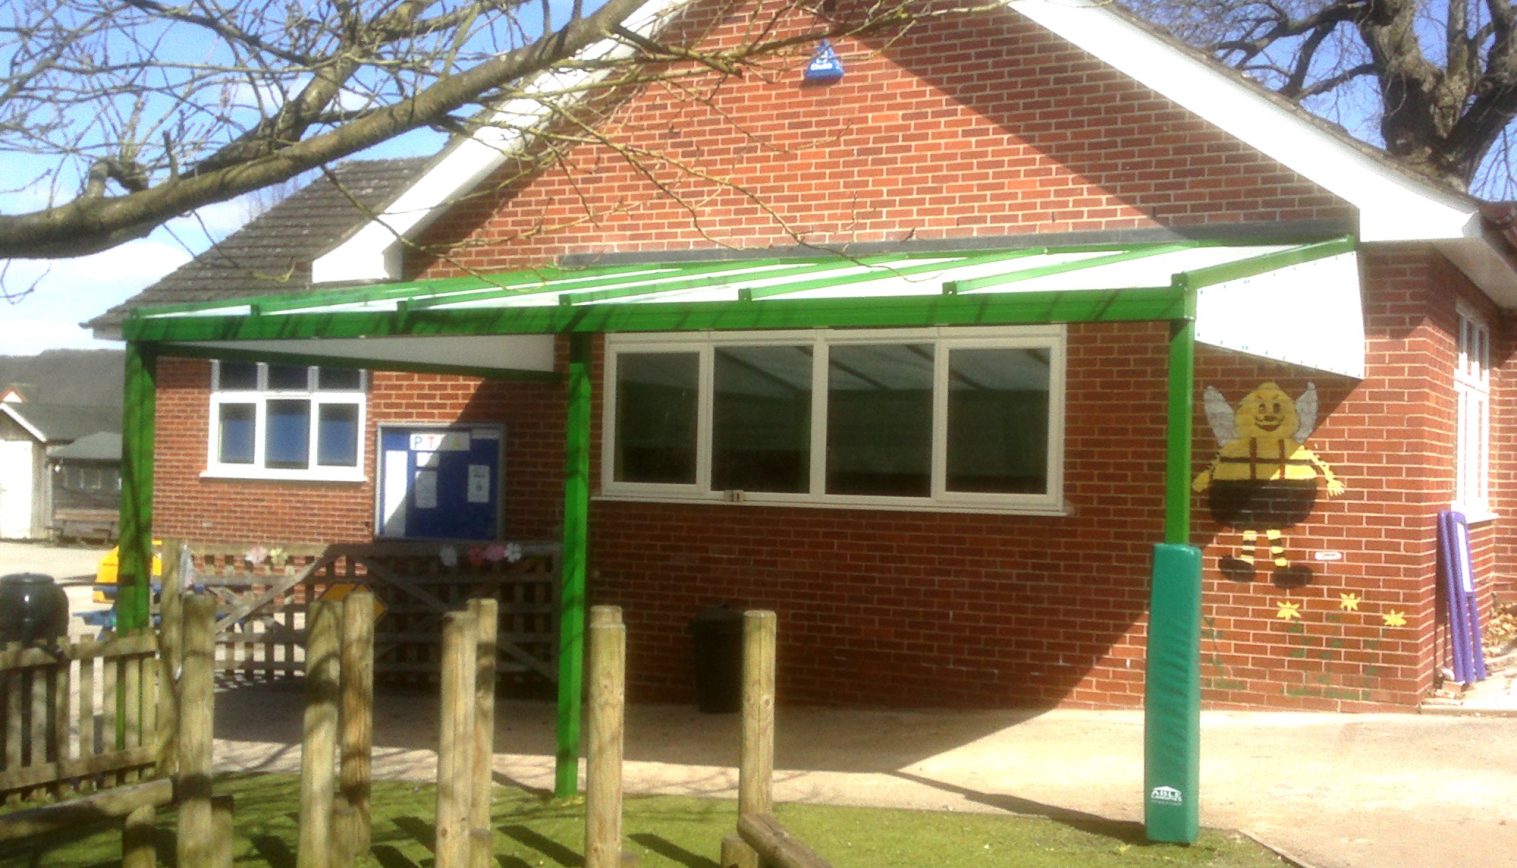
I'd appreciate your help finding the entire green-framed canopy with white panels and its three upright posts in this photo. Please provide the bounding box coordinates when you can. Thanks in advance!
[112,237,1364,841]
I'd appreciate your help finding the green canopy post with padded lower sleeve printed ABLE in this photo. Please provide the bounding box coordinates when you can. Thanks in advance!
[1144,301,1201,844]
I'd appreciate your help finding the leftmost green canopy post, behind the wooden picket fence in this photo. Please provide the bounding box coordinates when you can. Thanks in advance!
[115,341,158,633]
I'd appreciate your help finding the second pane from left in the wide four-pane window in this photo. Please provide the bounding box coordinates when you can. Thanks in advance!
[711,346,812,492]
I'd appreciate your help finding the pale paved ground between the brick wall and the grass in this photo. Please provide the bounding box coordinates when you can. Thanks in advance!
[0,543,1517,868]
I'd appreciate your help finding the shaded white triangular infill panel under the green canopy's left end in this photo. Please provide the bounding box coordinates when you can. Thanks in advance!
[169,334,554,373]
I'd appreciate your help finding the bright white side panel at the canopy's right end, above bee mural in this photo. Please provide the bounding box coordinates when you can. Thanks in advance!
[1195,253,1364,379]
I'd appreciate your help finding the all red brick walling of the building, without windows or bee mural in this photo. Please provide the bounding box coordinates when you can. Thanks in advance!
[136,0,1486,709]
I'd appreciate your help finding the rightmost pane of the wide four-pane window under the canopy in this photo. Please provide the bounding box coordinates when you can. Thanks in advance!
[948,349,1048,493]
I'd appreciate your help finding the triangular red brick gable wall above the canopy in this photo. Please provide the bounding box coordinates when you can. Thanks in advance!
[413,1,1350,275]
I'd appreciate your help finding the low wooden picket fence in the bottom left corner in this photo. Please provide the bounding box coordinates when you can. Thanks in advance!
[0,585,232,868]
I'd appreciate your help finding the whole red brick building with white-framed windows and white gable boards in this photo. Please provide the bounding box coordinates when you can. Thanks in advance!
[100,2,1517,710]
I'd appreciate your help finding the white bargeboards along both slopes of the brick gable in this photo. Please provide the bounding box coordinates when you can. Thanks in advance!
[313,0,1517,307]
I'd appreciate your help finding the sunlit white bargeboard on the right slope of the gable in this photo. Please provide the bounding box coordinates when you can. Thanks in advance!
[1007,0,1481,241]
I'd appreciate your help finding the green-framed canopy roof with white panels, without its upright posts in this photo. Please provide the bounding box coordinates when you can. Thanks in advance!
[124,238,1364,375]
